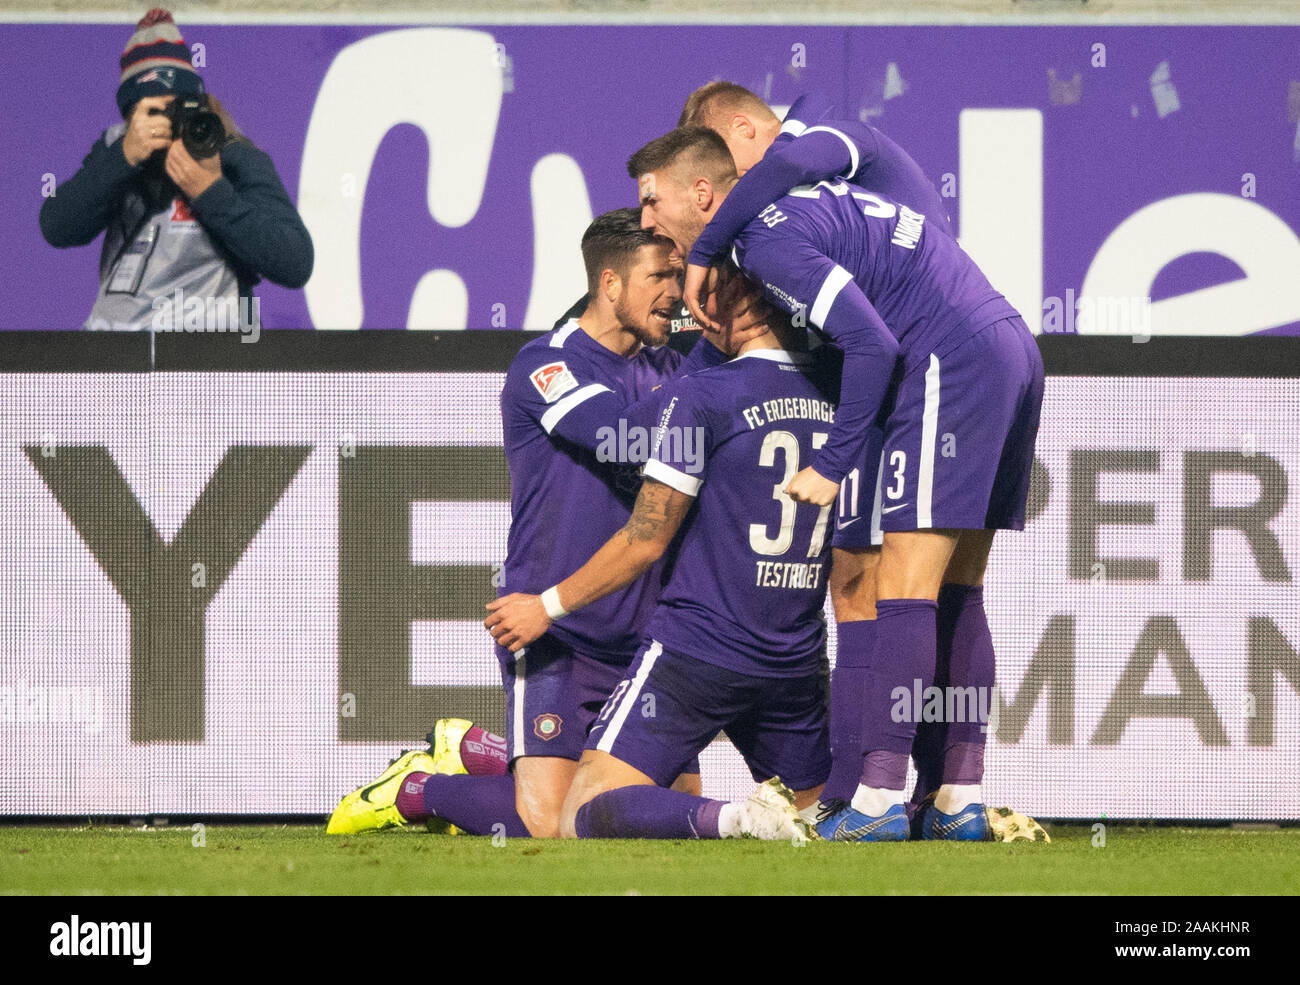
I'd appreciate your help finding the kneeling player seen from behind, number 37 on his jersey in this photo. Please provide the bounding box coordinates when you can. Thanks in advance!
[485,301,835,839]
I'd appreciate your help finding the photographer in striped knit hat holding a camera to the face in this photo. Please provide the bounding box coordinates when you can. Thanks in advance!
[40,9,313,330]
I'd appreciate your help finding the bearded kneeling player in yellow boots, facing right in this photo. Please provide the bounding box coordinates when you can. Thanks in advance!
[326,209,743,837]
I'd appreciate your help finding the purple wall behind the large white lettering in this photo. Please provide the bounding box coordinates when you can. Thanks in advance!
[0,23,1300,334]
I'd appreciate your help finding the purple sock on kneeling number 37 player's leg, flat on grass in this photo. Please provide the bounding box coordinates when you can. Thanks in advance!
[575,786,723,839]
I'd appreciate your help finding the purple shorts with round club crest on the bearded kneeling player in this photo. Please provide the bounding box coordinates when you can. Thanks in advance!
[495,635,699,769]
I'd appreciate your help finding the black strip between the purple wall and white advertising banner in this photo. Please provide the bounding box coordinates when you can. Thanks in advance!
[0,329,1300,378]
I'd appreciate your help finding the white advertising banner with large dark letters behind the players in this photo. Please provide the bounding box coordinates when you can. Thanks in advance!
[0,372,1300,819]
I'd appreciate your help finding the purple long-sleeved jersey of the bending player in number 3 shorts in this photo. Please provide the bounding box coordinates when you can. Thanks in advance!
[733,181,1018,482]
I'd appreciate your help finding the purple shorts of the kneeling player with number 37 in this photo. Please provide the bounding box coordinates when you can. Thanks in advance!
[586,641,831,790]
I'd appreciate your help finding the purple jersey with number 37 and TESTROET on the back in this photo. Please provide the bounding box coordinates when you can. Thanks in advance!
[645,350,835,677]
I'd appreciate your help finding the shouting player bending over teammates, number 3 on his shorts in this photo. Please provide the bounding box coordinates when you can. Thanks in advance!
[628,127,1043,841]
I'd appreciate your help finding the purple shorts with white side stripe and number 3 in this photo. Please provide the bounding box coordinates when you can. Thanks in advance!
[870,318,1043,531]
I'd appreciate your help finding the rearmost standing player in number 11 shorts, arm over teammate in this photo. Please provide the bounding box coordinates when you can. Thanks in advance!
[677,82,952,816]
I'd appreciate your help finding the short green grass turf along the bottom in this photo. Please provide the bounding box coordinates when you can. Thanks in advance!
[0,824,1300,895]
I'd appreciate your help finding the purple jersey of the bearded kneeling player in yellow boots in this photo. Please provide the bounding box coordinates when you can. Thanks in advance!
[501,321,723,664]
